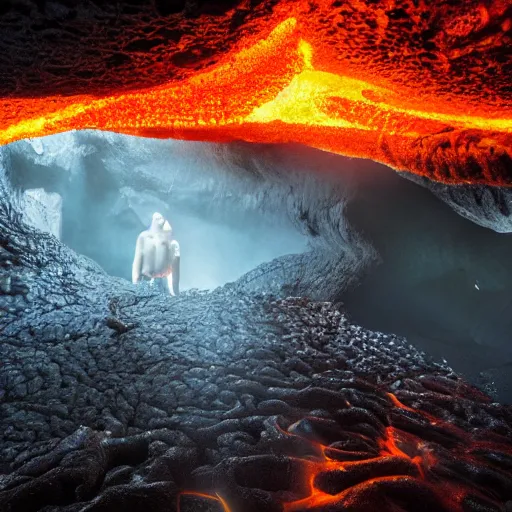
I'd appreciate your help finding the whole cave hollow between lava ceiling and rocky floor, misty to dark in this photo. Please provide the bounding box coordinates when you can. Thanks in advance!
[3,132,512,403]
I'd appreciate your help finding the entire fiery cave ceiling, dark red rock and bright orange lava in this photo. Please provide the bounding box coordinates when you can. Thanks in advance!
[0,0,512,186]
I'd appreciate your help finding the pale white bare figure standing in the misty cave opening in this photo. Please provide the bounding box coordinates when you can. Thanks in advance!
[132,212,180,295]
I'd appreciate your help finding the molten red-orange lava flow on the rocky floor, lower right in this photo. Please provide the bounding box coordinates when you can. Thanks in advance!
[268,393,510,512]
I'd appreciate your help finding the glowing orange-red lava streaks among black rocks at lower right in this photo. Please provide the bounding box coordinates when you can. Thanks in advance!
[277,393,510,512]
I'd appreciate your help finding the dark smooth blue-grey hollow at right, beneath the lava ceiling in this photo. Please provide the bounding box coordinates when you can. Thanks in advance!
[344,166,512,402]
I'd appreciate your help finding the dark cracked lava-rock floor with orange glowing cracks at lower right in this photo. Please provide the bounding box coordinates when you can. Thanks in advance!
[0,170,512,512]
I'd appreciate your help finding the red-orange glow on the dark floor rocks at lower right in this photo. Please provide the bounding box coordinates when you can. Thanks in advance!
[272,393,510,512]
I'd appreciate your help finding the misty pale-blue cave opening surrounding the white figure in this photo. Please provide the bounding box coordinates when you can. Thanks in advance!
[6,133,307,291]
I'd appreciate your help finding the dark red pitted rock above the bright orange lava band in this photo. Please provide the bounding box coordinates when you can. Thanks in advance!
[0,0,512,106]
